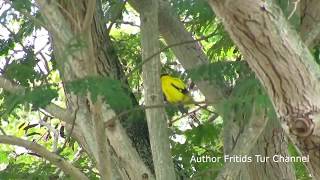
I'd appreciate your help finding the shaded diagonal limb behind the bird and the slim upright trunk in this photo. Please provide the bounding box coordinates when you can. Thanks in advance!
[129,0,226,105]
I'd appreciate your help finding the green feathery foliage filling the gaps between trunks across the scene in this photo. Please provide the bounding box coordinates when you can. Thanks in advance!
[0,0,320,179]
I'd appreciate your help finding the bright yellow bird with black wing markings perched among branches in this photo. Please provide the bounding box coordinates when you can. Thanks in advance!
[161,74,199,126]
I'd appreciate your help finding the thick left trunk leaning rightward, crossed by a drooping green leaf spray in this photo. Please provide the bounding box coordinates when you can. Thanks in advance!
[36,0,154,179]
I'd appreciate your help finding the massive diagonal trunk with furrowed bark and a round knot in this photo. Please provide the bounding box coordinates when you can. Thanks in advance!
[209,0,320,179]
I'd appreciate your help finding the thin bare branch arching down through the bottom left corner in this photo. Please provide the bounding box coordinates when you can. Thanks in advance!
[0,135,88,180]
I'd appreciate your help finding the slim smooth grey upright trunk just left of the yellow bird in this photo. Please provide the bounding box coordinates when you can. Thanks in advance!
[140,0,175,180]
